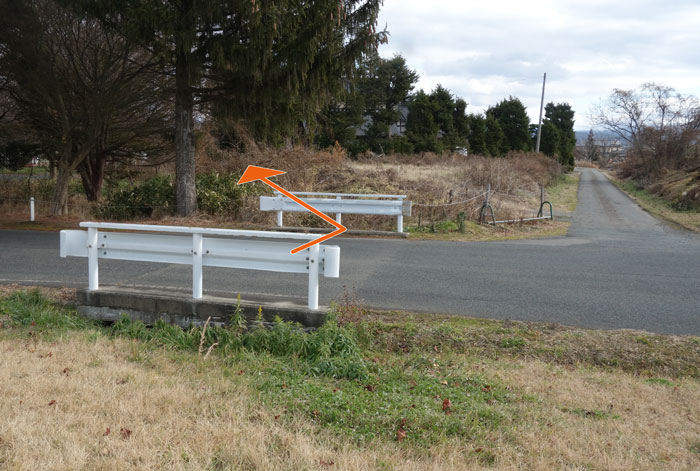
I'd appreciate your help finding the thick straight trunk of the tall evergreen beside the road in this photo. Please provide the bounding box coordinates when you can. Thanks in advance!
[175,42,197,216]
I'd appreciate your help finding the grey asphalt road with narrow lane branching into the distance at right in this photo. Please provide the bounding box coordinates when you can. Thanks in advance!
[0,169,700,335]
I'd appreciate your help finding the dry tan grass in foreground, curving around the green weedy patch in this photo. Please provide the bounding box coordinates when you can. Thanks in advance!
[0,335,700,470]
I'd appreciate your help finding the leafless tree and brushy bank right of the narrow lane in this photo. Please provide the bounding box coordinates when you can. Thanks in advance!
[586,83,700,231]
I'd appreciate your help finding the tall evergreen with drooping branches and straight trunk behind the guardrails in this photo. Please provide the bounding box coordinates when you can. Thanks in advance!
[71,0,386,216]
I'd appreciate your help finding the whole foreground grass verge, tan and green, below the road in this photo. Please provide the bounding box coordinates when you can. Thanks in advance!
[0,289,700,470]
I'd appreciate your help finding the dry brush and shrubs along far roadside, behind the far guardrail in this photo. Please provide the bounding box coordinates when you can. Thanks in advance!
[0,147,576,240]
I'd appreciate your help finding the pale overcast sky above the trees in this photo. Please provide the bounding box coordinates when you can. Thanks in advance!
[379,0,700,130]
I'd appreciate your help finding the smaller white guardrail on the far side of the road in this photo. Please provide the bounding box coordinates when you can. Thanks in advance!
[260,191,411,232]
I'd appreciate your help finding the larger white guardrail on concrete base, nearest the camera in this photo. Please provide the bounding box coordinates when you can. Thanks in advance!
[60,222,340,310]
